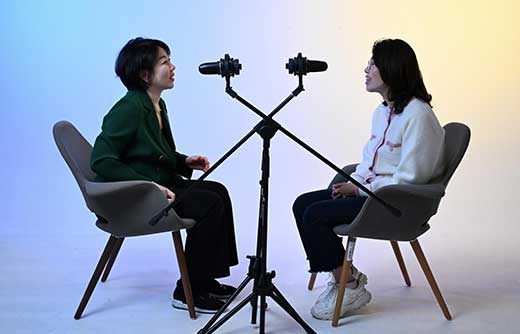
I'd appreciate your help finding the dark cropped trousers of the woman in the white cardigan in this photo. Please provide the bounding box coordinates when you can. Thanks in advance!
[293,189,366,273]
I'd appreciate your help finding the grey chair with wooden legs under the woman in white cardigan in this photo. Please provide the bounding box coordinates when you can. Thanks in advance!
[308,123,470,326]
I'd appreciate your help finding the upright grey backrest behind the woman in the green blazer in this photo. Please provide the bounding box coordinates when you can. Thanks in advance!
[52,121,96,206]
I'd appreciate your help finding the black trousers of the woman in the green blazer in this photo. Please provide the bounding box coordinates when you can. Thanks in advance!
[168,179,238,285]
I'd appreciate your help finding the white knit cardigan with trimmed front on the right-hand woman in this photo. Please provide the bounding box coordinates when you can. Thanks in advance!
[350,98,444,196]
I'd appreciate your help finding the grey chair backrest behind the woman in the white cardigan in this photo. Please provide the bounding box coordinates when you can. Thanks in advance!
[429,123,471,187]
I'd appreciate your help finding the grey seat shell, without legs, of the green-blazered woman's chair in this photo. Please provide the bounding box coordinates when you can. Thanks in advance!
[53,121,195,237]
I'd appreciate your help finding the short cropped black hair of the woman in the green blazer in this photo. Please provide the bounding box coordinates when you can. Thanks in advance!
[115,37,170,90]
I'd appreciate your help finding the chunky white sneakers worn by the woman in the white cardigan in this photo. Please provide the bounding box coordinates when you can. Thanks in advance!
[311,282,372,320]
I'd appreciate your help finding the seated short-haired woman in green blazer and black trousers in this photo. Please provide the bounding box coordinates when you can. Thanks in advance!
[91,37,238,313]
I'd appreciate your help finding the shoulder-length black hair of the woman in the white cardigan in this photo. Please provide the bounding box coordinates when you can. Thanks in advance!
[372,39,432,114]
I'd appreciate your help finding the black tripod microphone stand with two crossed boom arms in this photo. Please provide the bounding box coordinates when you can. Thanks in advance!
[149,61,401,334]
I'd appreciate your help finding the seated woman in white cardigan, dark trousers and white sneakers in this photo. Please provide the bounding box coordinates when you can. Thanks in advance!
[293,39,444,320]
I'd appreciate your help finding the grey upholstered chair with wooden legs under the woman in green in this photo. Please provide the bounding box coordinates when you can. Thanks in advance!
[53,121,195,319]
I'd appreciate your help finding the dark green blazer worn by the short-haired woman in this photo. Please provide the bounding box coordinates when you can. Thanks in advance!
[90,90,193,185]
